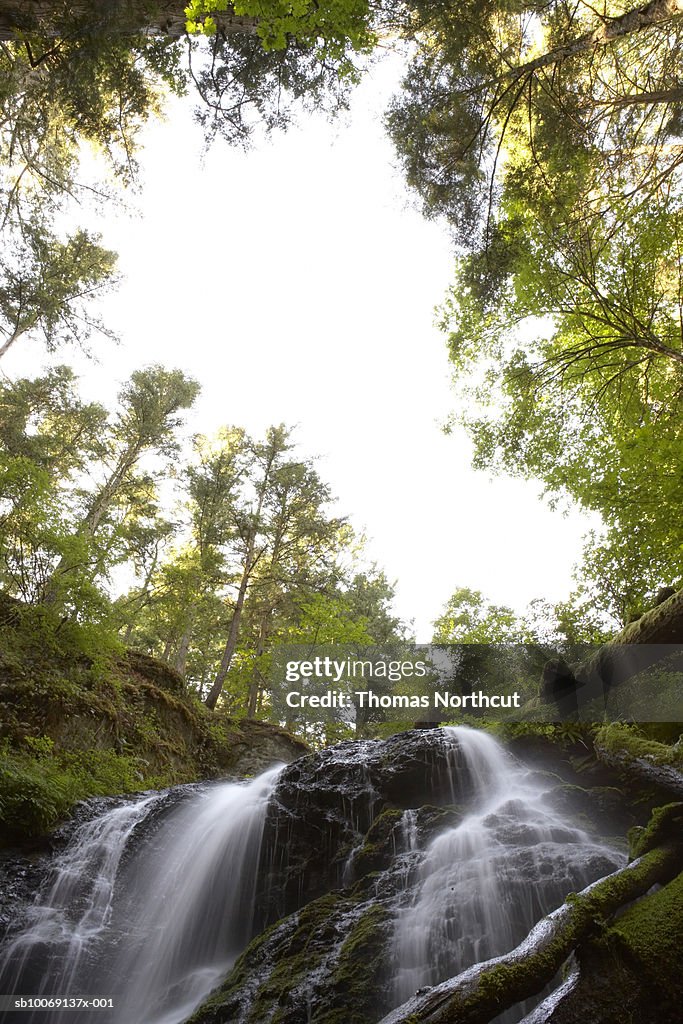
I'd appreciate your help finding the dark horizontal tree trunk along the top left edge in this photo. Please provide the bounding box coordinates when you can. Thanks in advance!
[0,0,258,41]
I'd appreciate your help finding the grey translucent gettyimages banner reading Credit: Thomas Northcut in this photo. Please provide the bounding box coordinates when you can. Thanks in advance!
[269,643,683,724]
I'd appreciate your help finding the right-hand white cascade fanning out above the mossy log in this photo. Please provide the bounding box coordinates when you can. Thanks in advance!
[393,726,624,1019]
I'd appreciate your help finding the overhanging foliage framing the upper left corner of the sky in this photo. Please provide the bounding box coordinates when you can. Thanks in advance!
[0,0,371,370]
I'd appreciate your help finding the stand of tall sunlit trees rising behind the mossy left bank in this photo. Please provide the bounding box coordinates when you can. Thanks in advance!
[0,367,402,726]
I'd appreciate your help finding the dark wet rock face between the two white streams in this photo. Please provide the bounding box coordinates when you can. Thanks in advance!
[257,729,472,923]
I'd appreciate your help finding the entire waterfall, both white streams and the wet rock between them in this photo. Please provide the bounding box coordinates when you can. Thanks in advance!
[0,726,624,1024]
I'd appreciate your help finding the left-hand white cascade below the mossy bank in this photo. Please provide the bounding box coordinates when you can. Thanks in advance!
[0,768,282,1024]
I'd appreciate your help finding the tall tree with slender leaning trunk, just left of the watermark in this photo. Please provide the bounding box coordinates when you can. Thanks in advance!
[119,426,358,716]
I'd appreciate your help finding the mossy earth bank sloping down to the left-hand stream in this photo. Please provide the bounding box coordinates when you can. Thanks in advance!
[0,594,282,844]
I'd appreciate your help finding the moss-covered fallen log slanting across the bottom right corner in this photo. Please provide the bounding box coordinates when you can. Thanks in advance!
[381,844,683,1024]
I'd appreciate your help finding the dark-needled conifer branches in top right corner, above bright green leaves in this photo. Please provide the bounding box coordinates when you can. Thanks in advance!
[387,0,683,240]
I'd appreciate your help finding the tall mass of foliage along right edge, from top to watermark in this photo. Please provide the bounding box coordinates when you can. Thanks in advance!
[387,0,683,622]
